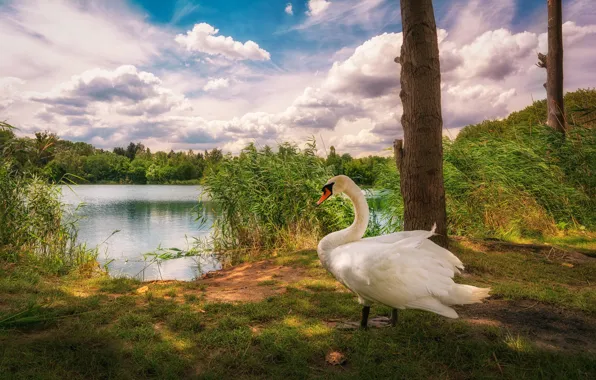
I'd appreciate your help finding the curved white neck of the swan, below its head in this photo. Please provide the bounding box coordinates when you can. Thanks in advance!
[317,182,369,264]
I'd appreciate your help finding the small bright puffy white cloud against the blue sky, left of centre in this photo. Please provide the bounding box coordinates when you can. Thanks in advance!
[175,22,271,61]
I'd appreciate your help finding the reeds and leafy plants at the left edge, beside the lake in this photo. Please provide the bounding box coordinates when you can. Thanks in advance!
[0,124,96,273]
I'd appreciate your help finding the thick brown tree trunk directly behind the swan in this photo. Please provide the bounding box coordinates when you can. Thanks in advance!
[399,0,447,247]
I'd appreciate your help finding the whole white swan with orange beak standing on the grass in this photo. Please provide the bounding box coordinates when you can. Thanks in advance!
[317,175,490,329]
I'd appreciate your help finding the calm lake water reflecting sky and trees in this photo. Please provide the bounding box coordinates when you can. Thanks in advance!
[62,185,220,281]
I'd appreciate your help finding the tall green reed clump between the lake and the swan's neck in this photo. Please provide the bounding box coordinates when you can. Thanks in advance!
[205,142,353,258]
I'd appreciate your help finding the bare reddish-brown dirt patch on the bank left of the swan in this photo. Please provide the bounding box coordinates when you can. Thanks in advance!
[198,260,308,302]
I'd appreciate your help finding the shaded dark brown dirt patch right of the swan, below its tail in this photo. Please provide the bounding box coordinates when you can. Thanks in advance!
[455,300,596,353]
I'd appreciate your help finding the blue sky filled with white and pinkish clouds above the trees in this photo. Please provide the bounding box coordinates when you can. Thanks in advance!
[0,0,596,157]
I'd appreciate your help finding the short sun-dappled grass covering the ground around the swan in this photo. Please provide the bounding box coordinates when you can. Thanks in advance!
[0,241,596,379]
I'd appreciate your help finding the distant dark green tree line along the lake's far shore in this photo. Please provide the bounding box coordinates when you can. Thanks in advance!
[0,129,388,186]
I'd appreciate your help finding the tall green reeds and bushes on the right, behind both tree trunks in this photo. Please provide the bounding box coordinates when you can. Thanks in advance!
[377,90,596,239]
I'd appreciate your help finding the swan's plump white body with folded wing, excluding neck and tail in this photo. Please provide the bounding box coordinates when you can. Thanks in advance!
[330,236,461,307]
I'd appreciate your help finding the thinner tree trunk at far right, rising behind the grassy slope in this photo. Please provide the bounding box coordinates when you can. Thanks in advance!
[546,0,565,134]
